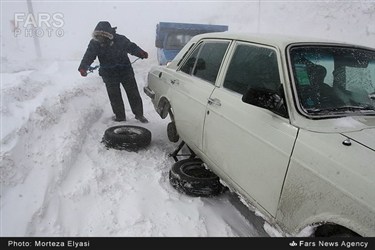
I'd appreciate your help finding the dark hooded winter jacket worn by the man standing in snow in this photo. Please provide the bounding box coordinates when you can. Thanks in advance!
[78,34,143,77]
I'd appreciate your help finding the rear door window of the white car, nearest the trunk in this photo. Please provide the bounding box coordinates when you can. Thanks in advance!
[181,41,229,83]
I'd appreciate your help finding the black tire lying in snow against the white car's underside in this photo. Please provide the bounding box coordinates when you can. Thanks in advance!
[169,158,226,197]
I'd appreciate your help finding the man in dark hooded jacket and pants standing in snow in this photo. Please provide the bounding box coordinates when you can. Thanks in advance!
[78,21,148,123]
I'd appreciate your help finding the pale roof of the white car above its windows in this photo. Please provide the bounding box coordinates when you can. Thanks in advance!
[192,32,373,49]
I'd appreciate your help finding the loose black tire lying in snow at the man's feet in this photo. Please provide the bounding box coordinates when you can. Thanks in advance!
[102,125,151,151]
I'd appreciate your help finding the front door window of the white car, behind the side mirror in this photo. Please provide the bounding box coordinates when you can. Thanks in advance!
[223,44,281,95]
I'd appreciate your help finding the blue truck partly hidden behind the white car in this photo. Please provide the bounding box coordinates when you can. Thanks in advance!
[155,22,228,65]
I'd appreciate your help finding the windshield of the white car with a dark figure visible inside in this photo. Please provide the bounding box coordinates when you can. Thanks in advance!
[289,46,375,117]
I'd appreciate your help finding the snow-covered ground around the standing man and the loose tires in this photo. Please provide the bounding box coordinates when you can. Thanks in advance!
[1,61,277,237]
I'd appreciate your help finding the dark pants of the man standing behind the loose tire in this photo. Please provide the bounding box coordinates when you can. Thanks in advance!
[103,75,143,119]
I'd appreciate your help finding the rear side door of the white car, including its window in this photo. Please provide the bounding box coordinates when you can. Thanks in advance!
[170,40,229,149]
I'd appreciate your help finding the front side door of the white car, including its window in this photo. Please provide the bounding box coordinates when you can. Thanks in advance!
[203,42,297,216]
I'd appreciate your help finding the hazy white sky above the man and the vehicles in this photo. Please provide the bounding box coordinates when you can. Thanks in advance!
[1,1,375,59]
